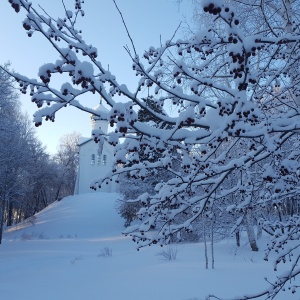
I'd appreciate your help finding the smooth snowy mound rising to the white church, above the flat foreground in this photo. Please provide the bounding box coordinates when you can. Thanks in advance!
[5,193,124,239]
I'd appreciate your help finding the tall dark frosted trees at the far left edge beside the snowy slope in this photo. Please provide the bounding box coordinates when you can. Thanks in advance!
[0,65,65,243]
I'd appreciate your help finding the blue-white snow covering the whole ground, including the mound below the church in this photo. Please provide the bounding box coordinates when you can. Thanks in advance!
[0,193,292,300]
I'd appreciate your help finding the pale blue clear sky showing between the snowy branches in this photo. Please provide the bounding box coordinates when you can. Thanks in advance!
[0,0,192,153]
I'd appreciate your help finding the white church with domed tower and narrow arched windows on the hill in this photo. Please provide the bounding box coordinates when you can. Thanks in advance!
[74,103,116,194]
